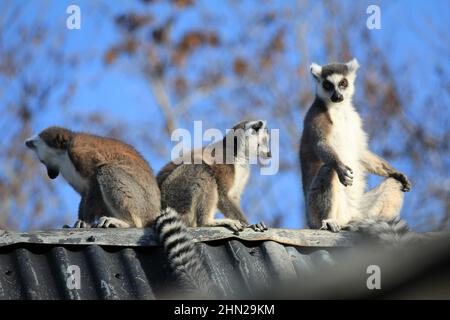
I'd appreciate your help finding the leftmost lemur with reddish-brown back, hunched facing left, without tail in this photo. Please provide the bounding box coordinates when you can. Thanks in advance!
[25,127,160,228]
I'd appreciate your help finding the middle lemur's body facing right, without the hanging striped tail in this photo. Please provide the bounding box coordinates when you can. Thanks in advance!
[157,120,271,232]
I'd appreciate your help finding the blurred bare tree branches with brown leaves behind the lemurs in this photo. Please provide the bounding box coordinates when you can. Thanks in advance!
[0,0,450,230]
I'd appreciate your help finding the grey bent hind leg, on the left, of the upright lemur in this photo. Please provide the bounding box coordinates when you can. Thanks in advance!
[306,165,341,232]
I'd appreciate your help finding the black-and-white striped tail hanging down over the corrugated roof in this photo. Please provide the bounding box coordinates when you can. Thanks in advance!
[155,208,215,298]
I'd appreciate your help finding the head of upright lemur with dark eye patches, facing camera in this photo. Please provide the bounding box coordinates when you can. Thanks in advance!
[311,59,359,103]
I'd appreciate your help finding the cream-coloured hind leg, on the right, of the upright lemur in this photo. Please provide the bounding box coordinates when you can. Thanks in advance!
[359,178,403,219]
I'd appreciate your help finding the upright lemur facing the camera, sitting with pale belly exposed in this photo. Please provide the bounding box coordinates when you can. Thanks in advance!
[300,59,411,232]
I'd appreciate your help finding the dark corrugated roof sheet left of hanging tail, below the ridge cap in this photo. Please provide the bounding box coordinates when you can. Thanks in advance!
[0,244,179,300]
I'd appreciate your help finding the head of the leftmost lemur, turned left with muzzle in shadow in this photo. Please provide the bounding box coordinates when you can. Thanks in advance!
[25,127,72,179]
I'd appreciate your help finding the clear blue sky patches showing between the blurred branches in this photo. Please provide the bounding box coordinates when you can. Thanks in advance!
[5,0,450,228]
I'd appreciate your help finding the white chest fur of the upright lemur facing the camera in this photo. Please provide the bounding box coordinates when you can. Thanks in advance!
[328,102,367,201]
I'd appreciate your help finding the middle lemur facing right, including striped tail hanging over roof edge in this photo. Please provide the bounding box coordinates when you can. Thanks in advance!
[155,120,271,297]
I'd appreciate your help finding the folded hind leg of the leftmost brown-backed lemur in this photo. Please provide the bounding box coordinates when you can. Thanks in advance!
[96,165,146,228]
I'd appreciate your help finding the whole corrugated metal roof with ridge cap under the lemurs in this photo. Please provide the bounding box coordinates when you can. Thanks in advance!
[0,228,344,299]
